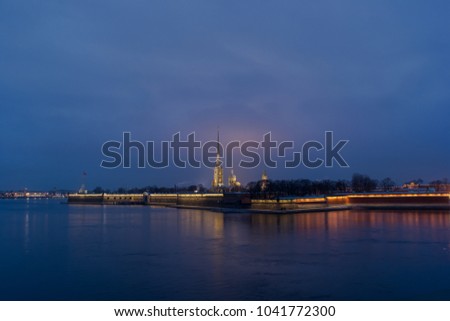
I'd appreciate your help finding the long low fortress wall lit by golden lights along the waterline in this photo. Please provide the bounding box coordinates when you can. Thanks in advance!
[68,193,450,213]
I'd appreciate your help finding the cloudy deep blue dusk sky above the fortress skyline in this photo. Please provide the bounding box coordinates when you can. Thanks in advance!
[0,0,450,190]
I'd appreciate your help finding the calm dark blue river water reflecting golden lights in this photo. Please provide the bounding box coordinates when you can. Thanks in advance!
[0,200,450,300]
